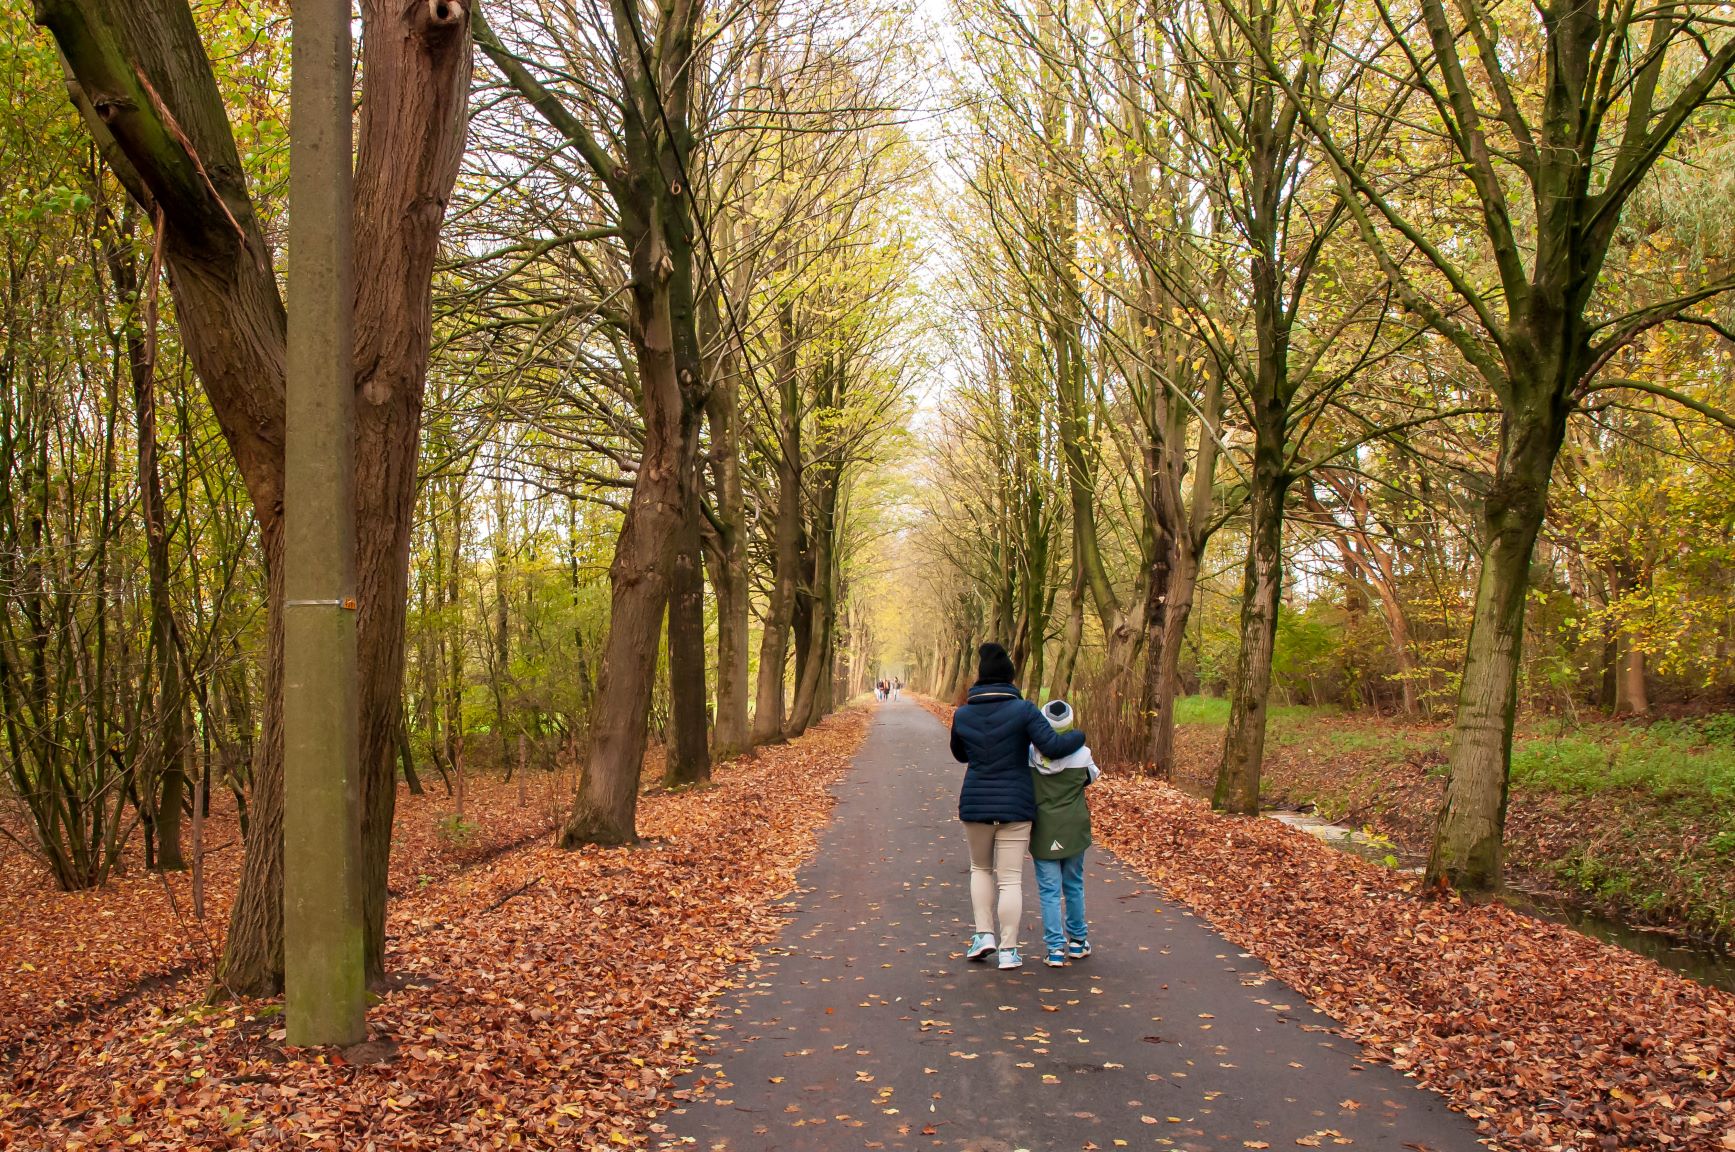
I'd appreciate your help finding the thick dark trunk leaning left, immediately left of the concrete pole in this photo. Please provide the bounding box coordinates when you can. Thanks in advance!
[36,0,285,964]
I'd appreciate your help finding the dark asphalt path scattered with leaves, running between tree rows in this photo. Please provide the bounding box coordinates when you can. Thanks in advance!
[659,701,1480,1152]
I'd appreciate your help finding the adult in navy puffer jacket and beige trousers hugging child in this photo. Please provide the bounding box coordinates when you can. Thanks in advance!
[953,644,1084,968]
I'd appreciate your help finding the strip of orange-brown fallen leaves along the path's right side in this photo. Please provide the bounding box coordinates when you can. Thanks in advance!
[925,701,1735,1152]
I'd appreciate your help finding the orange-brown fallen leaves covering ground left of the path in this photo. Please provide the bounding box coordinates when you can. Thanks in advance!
[0,711,868,1149]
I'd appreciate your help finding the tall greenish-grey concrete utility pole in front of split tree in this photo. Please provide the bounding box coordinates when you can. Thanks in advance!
[283,0,368,1044]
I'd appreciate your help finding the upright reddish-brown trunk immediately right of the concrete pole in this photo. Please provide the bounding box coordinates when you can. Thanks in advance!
[354,0,474,982]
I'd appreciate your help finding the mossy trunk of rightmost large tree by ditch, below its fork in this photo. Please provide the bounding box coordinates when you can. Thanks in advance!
[1428,400,1570,888]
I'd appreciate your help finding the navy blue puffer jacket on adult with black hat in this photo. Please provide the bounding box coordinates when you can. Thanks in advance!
[953,684,1084,824]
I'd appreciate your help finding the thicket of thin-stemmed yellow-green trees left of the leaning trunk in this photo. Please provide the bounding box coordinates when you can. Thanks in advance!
[0,0,264,888]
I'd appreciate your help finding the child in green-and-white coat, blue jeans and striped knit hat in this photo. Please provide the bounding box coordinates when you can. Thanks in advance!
[1031,699,1098,968]
